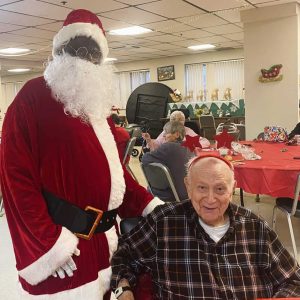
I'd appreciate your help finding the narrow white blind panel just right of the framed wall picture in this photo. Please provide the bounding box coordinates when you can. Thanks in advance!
[185,64,205,102]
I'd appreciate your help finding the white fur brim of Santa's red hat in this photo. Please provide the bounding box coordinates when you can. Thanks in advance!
[52,23,109,61]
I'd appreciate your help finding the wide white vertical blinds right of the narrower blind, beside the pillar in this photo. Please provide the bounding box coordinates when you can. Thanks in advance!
[206,59,244,100]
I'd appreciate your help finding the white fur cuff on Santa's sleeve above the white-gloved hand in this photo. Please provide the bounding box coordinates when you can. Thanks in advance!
[19,227,78,285]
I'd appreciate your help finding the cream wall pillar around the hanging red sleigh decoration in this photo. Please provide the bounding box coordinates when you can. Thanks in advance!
[242,3,299,139]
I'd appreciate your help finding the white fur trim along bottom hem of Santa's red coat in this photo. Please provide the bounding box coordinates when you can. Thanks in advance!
[20,267,115,300]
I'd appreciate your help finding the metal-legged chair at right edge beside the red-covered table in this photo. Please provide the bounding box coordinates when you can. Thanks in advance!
[272,174,300,259]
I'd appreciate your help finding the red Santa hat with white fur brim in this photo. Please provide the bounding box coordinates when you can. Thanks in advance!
[52,9,108,61]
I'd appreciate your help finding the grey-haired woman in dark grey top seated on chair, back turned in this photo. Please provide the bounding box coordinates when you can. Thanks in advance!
[142,121,194,201]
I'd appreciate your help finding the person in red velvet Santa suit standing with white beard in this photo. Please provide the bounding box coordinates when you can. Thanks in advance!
[1,9,162,300]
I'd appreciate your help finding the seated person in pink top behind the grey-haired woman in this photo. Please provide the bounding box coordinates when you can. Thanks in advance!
[143,110,210,151]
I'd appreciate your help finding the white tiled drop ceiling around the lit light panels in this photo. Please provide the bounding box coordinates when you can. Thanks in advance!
[0,0,296,75]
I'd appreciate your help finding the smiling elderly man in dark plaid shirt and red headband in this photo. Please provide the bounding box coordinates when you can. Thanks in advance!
[112,155,300,300]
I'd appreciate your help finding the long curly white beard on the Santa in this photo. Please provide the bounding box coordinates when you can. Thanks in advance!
[44,54,117,123]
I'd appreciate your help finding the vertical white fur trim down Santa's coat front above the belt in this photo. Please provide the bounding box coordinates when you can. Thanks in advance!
[91,120,126,210]
